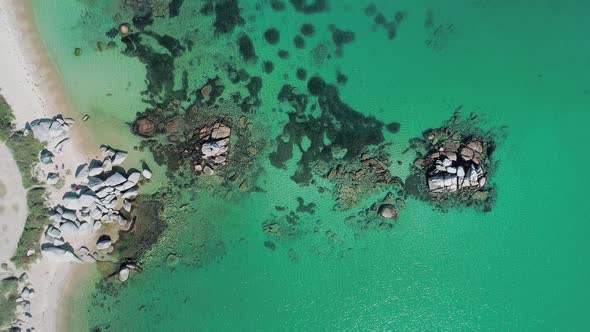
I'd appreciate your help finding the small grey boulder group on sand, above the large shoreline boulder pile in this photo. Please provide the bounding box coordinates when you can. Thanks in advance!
[25,115,74,150]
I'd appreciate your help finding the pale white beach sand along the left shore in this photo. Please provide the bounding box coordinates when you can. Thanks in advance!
[0,0,97,331]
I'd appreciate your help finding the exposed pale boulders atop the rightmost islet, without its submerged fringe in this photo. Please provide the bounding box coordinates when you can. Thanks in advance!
[426,138,487,195]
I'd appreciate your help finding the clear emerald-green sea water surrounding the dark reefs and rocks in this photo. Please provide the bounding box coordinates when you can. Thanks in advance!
[33,0,590,331]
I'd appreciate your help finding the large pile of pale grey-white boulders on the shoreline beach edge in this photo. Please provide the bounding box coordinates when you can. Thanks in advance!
[41,146,152,261]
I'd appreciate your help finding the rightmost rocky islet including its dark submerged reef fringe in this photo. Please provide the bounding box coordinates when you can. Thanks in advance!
[405,113,496,211]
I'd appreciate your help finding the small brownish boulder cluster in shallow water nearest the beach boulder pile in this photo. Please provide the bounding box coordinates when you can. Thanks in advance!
[194,122,231,175]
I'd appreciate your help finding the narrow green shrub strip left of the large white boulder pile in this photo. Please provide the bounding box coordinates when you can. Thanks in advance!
[12,188,50,267]
